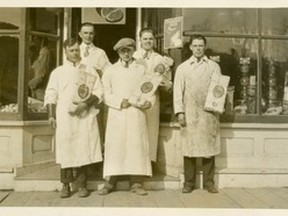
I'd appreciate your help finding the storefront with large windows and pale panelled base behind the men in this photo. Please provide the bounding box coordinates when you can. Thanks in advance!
[0,8,288,189]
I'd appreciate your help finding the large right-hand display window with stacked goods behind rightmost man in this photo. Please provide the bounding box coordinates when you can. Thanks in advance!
[143,8,288,123]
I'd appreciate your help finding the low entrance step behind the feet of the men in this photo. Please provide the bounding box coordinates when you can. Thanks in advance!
[14,165,180,191]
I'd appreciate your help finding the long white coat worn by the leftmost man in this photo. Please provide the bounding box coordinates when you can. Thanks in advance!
[45,61,103,168]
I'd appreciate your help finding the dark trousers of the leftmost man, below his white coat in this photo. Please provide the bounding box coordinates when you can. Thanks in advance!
[60,165,88,187]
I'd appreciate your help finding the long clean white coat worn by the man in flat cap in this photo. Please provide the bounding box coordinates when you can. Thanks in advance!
[102,61,152,177]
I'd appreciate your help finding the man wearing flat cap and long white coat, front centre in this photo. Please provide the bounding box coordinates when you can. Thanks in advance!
[98,38,152,195]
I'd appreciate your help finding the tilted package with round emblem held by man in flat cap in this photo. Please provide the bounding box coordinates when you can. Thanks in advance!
[128,63,166,106]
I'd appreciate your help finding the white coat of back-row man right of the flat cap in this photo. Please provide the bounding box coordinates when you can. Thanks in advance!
[133,49,165,162]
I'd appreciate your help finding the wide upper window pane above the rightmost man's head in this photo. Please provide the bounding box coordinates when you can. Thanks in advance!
[183,8,258,34]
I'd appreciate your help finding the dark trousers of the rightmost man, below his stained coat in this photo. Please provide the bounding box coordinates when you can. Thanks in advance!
[184,156,215,188]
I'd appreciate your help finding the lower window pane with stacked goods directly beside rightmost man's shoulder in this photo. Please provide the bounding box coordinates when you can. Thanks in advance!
[206,38,258,115]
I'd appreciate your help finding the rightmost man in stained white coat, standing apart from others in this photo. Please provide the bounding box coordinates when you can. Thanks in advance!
[173,35,221,193]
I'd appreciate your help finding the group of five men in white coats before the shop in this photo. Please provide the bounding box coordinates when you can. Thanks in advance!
[44,23,220,198]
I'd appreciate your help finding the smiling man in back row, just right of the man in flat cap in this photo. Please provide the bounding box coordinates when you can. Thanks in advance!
[133,28,173,165]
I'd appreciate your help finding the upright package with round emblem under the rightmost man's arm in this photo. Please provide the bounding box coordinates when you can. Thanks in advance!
[204,73,230,114]
